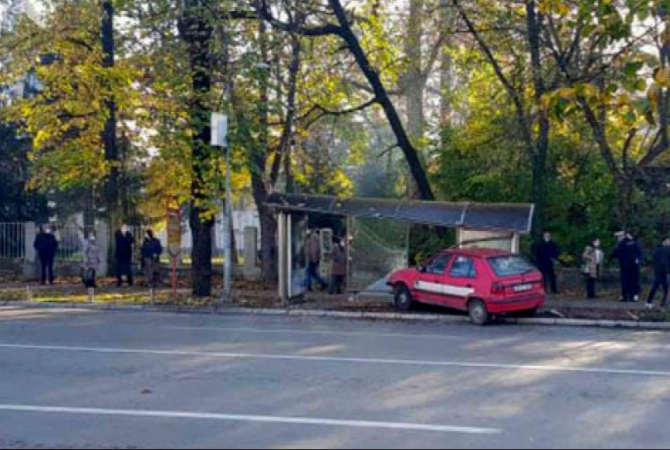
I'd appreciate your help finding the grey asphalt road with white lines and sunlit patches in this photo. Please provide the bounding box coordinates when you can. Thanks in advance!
[0,308,670,449]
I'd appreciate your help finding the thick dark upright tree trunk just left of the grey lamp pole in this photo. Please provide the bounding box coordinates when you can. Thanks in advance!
[179,0,214,297]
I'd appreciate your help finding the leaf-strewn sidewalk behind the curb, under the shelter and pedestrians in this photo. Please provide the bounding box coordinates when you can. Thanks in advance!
[0,284,670,324]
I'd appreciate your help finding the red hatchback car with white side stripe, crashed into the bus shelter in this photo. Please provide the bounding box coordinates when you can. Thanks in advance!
[388,248,546,325]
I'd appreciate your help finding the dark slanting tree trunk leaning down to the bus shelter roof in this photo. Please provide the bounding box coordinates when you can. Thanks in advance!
[329,0,435,200]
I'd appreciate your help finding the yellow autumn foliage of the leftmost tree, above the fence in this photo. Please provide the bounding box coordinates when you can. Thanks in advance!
[0,0,136,214]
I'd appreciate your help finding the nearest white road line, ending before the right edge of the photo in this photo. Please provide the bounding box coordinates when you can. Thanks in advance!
[0,405,502,435]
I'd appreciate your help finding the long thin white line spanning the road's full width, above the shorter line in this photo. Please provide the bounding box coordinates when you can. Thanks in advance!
[0,344,670,378]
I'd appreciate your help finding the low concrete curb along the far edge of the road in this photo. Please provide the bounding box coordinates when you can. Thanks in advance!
[0,302,670,331]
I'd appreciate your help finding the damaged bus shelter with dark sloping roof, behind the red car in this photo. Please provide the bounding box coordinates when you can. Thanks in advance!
[267,193,535,301]
